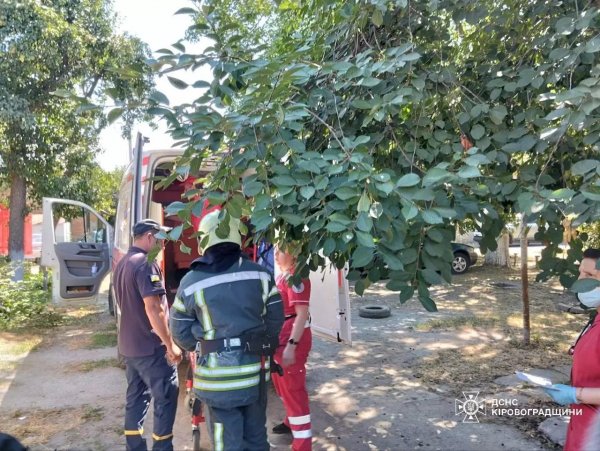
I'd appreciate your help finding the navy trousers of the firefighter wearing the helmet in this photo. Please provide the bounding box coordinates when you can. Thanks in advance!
[203,393,269,451]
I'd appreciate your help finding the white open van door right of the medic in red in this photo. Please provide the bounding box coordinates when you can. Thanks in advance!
[310,260,352,345]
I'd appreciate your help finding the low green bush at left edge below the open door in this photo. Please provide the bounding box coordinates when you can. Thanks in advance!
[0,261,62,329]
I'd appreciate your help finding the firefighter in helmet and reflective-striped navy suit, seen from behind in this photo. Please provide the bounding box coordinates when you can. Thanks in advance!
[171,210,283,451]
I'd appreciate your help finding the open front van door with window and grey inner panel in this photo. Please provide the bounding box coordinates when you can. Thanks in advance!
[41,197,113,302]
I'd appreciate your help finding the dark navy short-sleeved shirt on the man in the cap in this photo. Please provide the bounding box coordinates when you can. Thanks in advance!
[113,246,168,357]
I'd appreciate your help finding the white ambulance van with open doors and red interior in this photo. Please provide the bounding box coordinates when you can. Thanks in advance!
[41,134,351,344]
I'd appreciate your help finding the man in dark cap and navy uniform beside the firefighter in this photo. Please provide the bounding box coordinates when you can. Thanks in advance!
[113,219,181,451]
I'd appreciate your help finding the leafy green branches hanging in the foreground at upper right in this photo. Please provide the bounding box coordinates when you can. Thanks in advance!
[145,0,600,310]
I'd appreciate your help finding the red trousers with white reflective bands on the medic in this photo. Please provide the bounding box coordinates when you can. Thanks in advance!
[272,326,312,451]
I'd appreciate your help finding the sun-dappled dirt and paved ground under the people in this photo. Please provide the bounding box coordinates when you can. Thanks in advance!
[0,266,585,451]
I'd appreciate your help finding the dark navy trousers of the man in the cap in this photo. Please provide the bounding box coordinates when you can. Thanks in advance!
[125,346,179,451]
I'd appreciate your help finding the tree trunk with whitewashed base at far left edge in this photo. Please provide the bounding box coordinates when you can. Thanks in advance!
[8,174,27,281]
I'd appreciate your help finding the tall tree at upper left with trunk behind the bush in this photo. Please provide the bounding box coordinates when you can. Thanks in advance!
[0,0,152,278]
